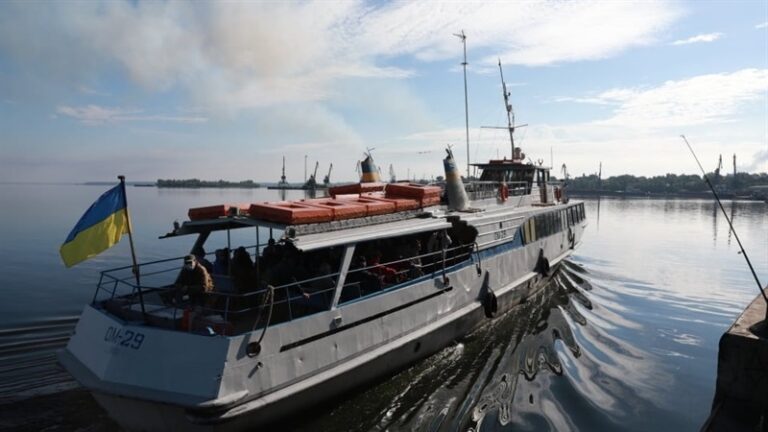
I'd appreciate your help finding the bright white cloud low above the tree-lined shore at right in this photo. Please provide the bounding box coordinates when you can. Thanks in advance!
[402,69,768,175]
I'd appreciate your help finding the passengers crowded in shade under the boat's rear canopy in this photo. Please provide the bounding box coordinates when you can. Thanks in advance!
[168,231,451,314]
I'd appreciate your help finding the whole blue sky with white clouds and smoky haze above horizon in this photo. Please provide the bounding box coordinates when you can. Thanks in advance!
[0,0,768,182]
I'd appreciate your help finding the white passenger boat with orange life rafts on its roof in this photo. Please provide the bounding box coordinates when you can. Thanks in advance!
[59,65,586,431]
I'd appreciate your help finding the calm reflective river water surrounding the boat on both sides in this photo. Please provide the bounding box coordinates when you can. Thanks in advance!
[0,184,768,431]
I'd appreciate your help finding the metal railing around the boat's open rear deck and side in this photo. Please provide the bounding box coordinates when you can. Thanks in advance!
[93,241,472,335]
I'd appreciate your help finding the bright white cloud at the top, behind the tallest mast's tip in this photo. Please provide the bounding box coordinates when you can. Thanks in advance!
[362,1,680,66]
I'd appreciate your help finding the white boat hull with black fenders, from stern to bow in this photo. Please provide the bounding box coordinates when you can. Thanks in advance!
[60,204,586,431]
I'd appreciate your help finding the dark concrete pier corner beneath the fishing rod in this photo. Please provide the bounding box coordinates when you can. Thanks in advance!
[702,295,768,432]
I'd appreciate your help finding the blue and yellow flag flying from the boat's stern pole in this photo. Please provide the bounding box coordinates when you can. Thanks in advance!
[59,185,128,267]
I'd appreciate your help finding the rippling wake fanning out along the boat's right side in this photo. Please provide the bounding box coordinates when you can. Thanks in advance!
[297,260,684,431]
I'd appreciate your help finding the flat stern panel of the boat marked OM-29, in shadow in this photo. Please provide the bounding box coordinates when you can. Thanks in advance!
[58,305,229,429]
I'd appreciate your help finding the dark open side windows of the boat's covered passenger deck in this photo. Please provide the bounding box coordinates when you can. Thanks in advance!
[213,226,476,325]
